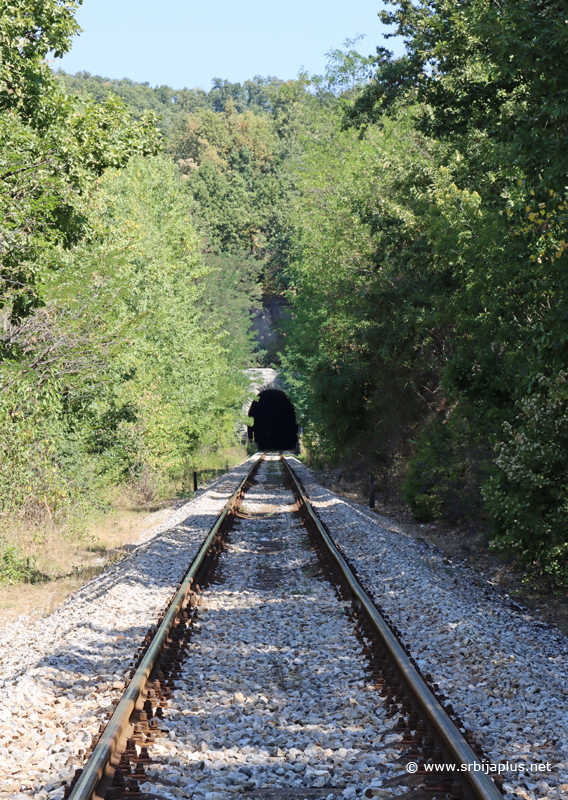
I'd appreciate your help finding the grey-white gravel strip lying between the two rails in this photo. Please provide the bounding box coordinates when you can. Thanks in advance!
[140,461,405,800]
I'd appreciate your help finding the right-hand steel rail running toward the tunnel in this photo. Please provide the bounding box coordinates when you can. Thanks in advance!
[282,456,503,800]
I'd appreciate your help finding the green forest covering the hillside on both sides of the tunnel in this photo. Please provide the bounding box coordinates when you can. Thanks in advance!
[4,0,568,583]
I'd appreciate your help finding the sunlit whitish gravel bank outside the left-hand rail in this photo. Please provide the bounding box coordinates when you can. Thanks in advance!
[0,464,255,800]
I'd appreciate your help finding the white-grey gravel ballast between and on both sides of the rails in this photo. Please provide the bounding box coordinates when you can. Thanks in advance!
[0,457,568,800]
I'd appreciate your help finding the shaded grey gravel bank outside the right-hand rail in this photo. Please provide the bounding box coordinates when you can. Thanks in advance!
[286,459,568,800]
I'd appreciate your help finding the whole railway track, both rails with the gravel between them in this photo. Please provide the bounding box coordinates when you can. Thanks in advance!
[65,455,501,800]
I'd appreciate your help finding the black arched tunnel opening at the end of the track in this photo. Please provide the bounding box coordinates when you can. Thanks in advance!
[248,389,298,450]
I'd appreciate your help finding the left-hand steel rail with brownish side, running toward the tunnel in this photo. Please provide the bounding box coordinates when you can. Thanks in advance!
[69,455,264,800]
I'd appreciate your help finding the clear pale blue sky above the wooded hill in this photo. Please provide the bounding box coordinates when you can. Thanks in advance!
[53,0,402,89]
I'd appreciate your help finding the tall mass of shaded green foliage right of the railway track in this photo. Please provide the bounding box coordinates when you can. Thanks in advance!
[287,0,568,580]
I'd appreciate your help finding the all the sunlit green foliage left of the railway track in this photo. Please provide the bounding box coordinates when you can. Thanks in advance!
[0,0,258,578]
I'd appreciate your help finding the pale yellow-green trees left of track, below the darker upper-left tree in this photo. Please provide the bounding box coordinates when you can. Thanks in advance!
[0,157,248,518]
